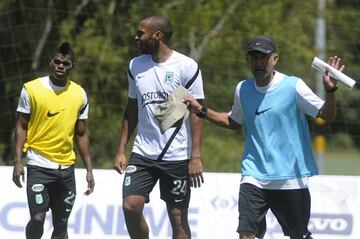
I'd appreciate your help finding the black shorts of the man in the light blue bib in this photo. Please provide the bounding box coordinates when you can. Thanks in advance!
[237,183,311,239]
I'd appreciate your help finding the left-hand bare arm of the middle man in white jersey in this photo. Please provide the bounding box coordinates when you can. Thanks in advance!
[114,98,138,174]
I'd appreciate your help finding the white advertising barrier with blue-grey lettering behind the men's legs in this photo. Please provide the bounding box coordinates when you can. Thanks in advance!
[0,167,360,239]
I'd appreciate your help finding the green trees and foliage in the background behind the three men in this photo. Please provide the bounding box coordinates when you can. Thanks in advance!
[0,0,360,172]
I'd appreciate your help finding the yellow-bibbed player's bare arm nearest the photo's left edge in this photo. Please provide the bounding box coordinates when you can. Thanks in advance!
[13,113,30,188]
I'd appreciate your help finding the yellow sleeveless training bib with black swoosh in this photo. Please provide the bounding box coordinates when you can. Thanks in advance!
[24,78,83,166]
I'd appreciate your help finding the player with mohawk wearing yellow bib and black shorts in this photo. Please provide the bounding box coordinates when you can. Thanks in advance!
[13,42,95,239]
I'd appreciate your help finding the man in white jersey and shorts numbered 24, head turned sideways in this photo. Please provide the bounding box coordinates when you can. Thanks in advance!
[114,16,204,239]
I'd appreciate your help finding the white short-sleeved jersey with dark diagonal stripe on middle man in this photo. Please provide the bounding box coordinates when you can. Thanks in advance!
[128,51,204,161]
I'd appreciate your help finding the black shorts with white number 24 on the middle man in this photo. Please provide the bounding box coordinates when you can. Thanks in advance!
[123,153,191,208]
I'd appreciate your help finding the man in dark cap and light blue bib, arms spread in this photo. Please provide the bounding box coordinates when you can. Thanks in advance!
[186,36,344,239]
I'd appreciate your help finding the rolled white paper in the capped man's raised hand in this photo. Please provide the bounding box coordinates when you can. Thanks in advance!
[311,57,356,90]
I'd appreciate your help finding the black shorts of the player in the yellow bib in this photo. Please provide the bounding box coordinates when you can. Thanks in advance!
[27,165,76,217]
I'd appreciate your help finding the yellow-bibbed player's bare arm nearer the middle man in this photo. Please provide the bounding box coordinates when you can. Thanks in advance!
[75,120,95,195]
